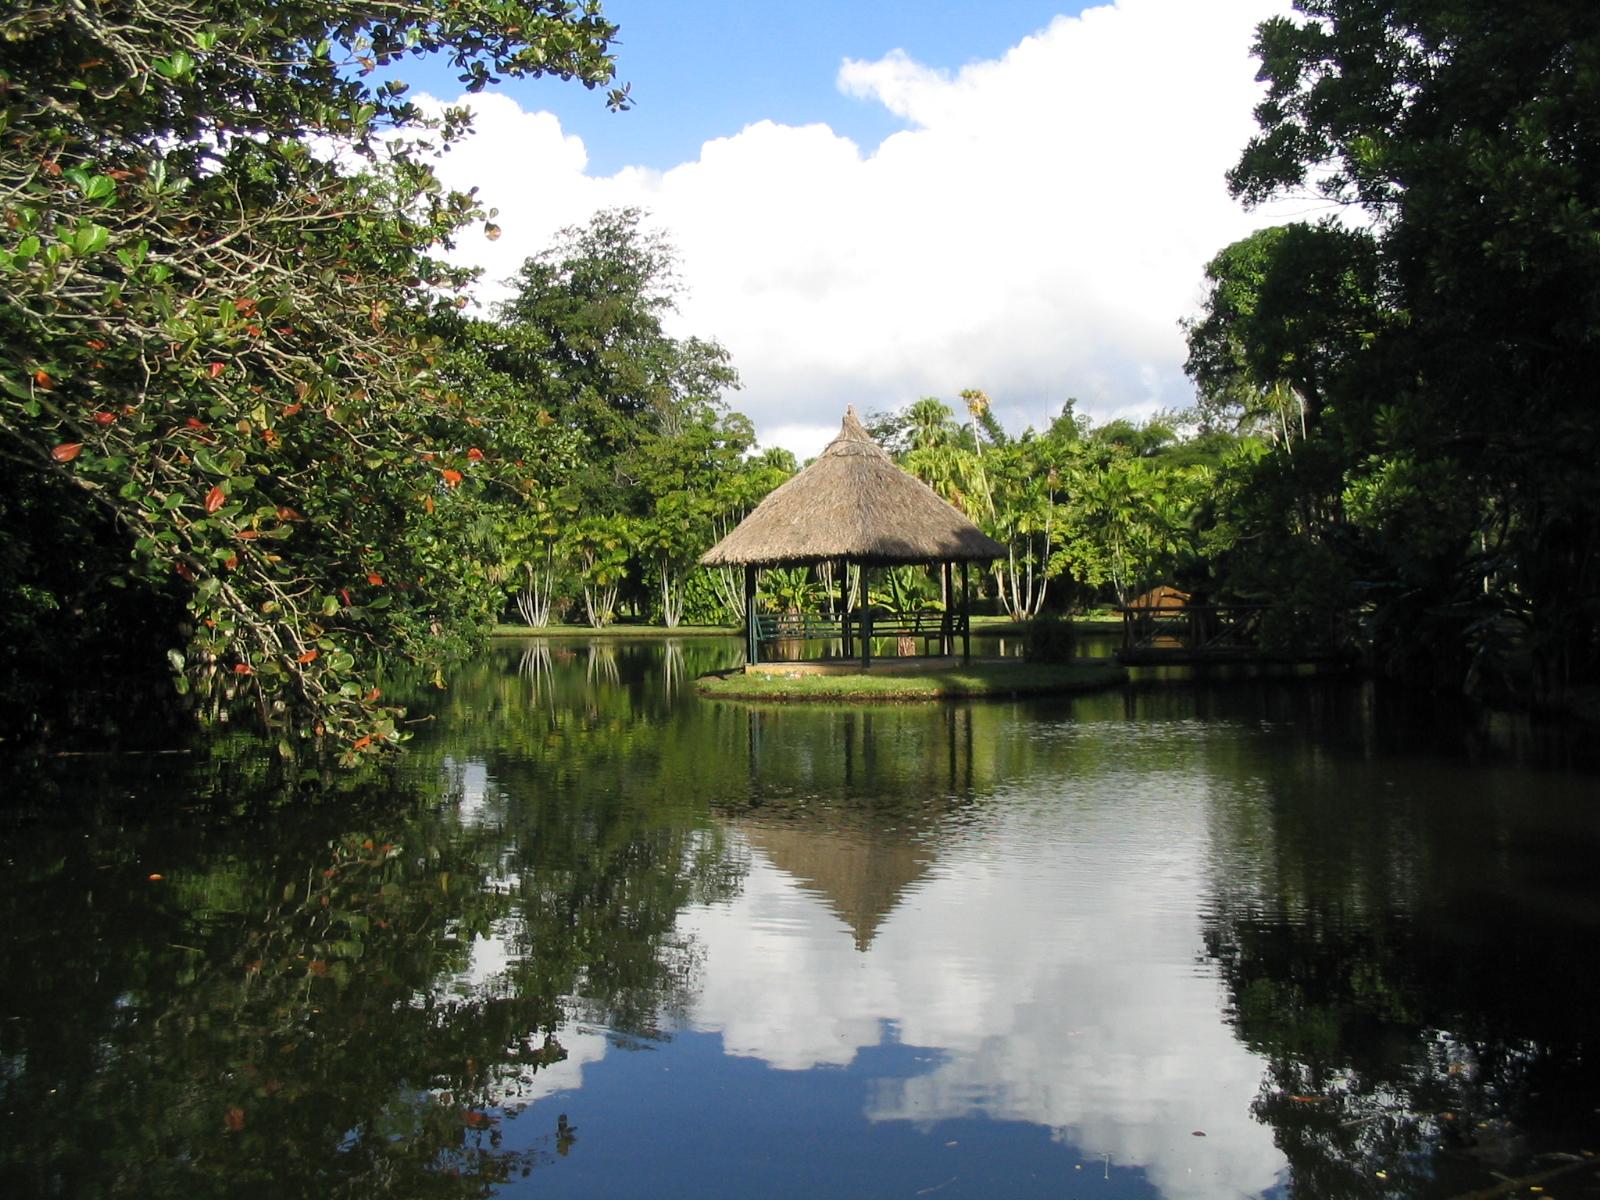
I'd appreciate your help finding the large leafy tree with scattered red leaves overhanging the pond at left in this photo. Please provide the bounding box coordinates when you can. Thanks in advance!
[0,0,626,752]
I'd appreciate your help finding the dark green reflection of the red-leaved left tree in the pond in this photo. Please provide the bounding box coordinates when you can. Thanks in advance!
[0,720,736,1197]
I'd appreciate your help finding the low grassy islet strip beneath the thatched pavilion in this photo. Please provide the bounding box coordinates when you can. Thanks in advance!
[698,659,1128,702]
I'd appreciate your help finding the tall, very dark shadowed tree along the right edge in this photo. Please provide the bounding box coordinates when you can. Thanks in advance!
[1209,0,1600,701]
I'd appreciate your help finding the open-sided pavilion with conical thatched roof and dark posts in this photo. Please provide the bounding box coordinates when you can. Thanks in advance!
[701,406,1005,667]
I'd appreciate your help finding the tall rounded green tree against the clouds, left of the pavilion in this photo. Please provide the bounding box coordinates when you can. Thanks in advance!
[485,208,739,626]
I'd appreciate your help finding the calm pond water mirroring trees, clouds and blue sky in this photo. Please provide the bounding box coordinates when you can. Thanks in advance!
[0,640,1600,1200]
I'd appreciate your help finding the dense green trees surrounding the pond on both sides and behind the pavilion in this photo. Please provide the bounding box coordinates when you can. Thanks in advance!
[0,0,1600,755]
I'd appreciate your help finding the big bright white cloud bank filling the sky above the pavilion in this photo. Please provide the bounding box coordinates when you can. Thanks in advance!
[419,0,1285,453]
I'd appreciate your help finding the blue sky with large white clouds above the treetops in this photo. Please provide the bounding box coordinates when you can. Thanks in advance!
[396,0,1315,458]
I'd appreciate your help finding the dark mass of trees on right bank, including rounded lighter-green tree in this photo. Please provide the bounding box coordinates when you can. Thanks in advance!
[1189,0,1600,704]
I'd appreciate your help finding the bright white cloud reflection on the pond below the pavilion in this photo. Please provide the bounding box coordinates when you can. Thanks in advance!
[683,790,1285,1197]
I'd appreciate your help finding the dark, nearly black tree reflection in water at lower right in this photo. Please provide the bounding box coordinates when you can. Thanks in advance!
[1205,742,1600,1197]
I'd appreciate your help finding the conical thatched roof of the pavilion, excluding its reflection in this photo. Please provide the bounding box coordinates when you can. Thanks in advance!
[701,408,1005,566]
